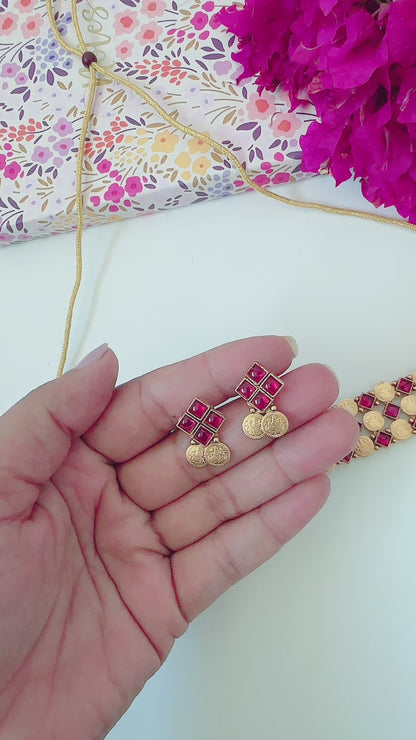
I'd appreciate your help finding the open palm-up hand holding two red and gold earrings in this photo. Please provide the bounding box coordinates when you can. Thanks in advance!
[0,337,357,740]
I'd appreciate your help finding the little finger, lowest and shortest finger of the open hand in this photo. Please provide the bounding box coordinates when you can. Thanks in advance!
[171,475,330,621]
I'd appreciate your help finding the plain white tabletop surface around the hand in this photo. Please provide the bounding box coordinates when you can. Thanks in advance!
[0,178,416,740]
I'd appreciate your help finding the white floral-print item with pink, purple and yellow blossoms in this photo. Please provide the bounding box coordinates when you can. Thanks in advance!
[0,0,314,245]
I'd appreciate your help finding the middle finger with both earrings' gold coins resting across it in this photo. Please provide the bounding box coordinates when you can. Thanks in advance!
[118,365,338,511]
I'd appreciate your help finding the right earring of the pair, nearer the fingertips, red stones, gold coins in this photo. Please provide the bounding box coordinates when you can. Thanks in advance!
[235,362,289,439]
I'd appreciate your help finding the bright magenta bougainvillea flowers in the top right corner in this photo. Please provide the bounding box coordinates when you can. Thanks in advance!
[218,0,416,223]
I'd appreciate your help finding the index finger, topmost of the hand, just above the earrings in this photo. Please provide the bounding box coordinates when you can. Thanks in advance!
[86,337,293,462]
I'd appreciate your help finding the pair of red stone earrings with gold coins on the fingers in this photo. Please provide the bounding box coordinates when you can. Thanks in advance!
[176,362,289,468]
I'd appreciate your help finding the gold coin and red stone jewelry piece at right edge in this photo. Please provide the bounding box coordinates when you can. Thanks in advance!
[337,370,416,464]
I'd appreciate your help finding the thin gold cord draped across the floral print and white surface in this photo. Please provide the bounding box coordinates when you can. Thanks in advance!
[46,0,416,377]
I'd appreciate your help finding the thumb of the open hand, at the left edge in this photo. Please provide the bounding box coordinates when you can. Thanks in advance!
[0,344,118,522]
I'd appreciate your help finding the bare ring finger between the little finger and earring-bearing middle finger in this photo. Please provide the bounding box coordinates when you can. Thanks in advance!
[153,408,359,550]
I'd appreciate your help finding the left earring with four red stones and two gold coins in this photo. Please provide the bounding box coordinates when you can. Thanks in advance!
[176,398,231,468]
